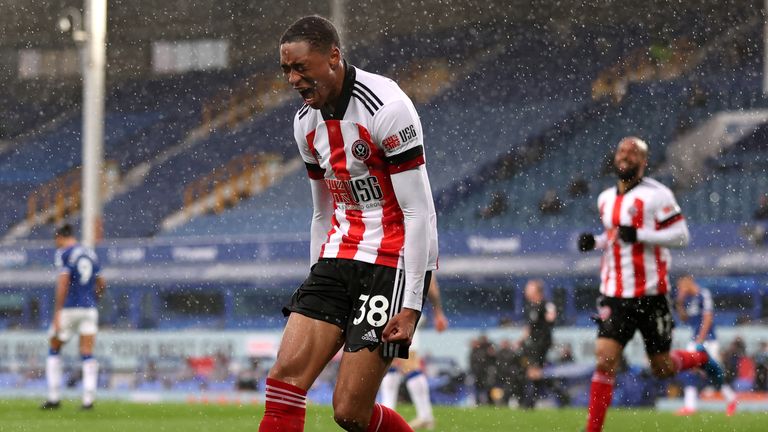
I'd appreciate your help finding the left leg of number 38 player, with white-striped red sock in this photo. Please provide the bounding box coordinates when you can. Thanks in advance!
[259,313,343,432]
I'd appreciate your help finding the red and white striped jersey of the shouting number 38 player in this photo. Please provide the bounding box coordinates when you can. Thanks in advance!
[294,64,437,270]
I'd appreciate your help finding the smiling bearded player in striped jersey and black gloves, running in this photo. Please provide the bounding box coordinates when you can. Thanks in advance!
[578,137,723,431]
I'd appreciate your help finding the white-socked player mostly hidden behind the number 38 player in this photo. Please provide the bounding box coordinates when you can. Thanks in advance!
[381,275,448,430]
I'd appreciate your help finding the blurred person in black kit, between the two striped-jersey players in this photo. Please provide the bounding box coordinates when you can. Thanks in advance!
[518,279,557,408]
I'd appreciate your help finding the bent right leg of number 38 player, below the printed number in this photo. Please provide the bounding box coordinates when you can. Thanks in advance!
[333,347,412,432]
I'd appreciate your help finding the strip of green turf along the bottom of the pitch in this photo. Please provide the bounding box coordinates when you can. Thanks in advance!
[0,400,768,432]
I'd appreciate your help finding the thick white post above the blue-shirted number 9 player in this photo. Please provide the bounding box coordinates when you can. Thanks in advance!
[82,0,107,247]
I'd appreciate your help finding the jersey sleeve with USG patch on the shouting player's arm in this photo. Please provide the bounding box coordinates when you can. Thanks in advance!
[372,99,424,174]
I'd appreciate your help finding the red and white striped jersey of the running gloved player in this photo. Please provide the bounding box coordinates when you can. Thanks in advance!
[597,177,687,298]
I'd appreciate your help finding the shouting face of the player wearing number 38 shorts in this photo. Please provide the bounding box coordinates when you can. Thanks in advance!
[280,41,341,109]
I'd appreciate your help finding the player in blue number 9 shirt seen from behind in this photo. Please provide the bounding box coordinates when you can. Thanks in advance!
[41,225,106,409]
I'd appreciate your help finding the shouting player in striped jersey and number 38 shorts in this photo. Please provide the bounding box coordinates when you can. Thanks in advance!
[259,16,437,432]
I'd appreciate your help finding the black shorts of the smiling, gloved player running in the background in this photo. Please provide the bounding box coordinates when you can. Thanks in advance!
[597,295,675,356]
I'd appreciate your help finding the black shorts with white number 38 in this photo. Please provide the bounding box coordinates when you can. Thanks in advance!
[283,258,432,358]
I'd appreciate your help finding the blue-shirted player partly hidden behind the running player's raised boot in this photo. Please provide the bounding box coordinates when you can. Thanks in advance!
[675,275,737,416]
